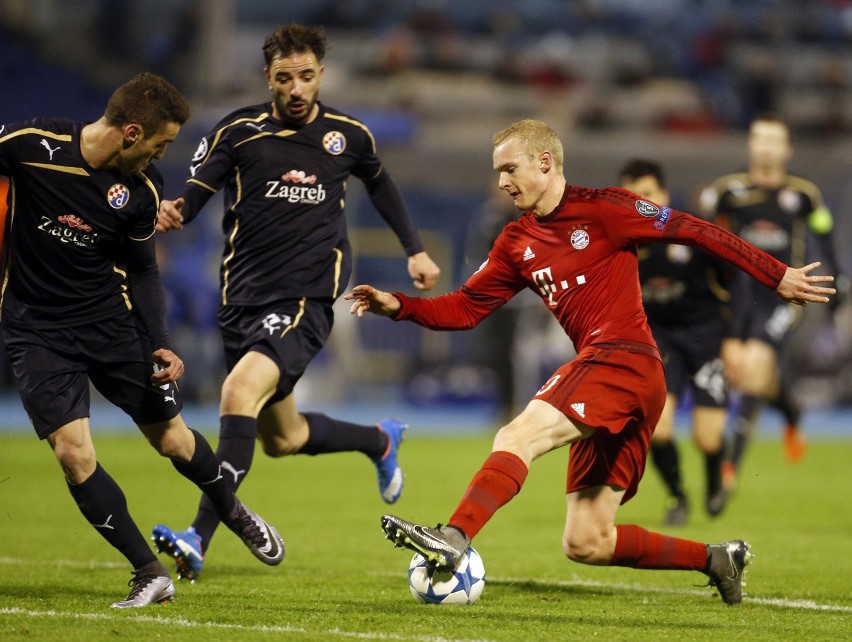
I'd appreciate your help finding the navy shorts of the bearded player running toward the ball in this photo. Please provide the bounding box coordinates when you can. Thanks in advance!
[219,298,334,406]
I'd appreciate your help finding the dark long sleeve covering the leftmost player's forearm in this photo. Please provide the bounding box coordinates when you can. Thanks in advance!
[125,237,171,350]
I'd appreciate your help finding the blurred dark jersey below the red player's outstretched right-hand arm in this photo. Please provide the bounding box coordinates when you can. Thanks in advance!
[639,243,731,328]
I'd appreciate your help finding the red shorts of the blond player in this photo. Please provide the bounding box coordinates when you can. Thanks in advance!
[533,341,666,504]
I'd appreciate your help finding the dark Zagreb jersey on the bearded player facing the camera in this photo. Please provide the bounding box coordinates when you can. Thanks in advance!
[183,103,419,305]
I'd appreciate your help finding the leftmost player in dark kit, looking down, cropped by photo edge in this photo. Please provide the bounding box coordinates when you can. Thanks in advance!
[0,73,284,608]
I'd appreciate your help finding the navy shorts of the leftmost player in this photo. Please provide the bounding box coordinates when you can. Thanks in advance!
[3,316,182,439]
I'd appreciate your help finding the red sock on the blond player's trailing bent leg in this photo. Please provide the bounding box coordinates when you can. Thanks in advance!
[609,524,707,571]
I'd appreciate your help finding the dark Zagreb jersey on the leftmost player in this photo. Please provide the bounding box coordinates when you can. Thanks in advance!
[0,118,162,327]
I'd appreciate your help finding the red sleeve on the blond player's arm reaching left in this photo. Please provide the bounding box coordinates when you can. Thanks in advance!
[393,231,527,330]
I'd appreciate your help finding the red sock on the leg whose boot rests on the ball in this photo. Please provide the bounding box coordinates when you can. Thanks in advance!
[447,450,528,539]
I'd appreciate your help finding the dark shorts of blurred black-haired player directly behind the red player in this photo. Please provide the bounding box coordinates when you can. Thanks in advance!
[651,318,728,408]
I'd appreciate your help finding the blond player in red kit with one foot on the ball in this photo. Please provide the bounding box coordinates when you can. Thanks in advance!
[346,120,834,604]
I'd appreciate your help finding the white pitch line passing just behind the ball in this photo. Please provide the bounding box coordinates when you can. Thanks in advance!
[0,557,852,612]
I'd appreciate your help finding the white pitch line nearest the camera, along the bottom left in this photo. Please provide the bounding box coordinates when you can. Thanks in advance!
[0,608,490,642]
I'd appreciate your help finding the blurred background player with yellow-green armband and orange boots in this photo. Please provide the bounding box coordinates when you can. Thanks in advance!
[701,114,845,490]
